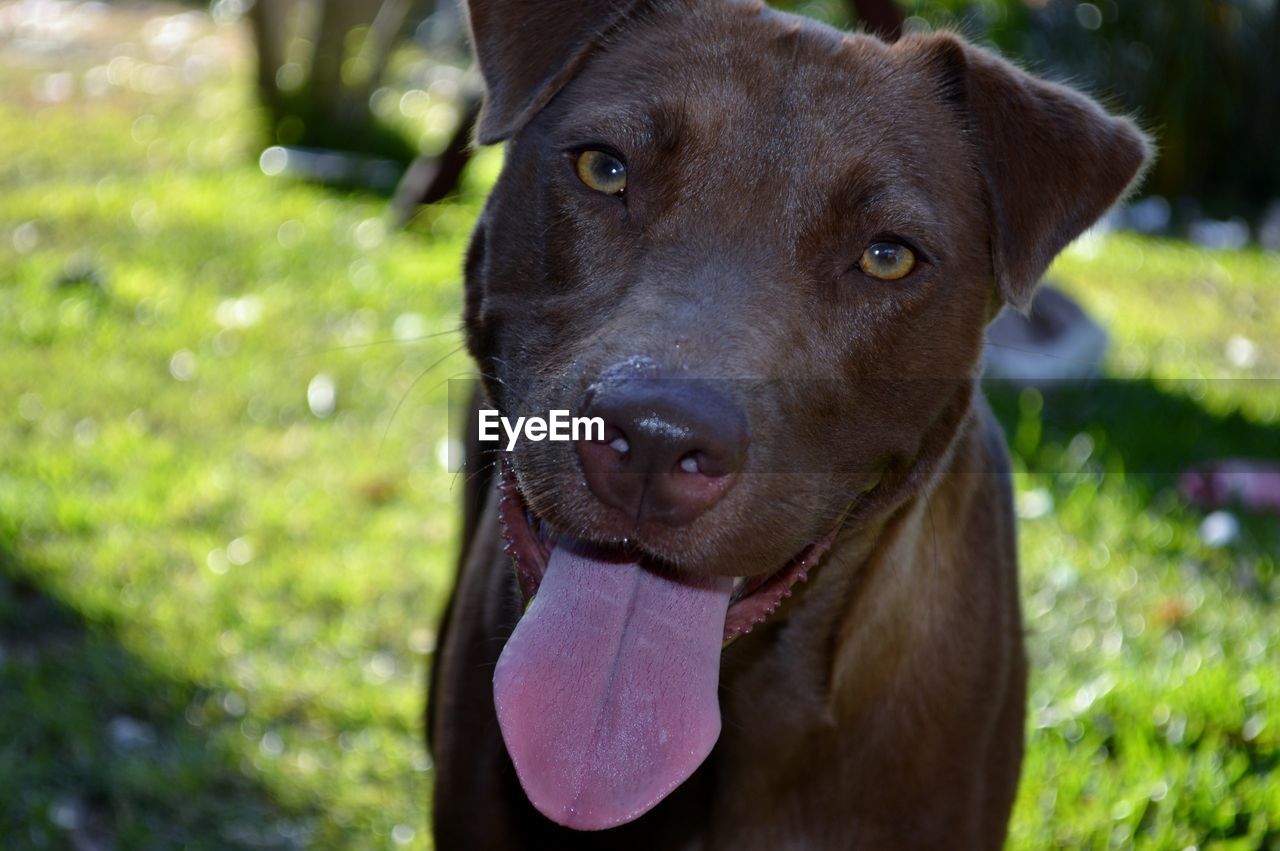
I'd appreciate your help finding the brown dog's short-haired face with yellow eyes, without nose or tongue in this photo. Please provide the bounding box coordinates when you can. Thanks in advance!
[467,3,1142,576]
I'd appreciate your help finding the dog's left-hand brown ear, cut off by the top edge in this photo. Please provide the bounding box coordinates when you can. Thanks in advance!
[467,0,649,145]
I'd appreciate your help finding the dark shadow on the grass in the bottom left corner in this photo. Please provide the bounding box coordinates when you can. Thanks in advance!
[0,543,308,851]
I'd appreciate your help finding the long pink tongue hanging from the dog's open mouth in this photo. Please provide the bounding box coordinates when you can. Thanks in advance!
[493,546,732,831]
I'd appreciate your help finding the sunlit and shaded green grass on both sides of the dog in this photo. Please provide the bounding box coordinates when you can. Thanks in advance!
[0,8,1280,851]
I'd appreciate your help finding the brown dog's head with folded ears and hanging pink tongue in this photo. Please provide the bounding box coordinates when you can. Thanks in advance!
[466,0,1147,828]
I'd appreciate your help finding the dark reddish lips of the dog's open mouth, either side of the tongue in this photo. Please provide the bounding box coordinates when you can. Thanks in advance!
[498,461,840,644]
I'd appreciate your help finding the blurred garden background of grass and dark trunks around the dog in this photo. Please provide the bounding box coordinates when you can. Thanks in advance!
[0,0,1280,850]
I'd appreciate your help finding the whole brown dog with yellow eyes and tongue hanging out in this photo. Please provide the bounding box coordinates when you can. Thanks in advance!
[429,0,1147,851]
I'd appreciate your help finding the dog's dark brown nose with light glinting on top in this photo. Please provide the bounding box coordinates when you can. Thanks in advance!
[577,370,750,526]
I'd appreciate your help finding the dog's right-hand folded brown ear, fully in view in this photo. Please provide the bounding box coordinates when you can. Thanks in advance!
[902,35,1151,310]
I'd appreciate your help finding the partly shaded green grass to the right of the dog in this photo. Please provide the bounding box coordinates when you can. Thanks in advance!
[992,237,1280,850]
